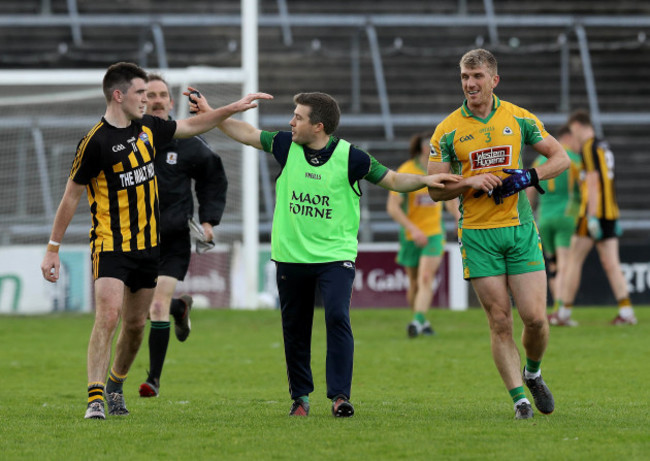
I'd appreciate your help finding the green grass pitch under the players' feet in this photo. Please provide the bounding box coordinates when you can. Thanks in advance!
[0,307,650,461]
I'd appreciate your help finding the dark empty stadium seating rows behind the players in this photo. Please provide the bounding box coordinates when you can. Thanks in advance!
[0,0,650,243]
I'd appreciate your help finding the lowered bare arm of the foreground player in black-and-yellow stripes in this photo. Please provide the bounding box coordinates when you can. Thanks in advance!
[41,179,86,283]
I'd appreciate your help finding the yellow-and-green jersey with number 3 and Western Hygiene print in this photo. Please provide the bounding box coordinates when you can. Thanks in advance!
[429,96,548,229]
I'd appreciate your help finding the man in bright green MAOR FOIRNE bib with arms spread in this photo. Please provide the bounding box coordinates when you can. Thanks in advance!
[191,93,460,417]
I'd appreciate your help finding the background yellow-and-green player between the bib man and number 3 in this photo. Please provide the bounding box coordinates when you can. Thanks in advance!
[386,132,460,338]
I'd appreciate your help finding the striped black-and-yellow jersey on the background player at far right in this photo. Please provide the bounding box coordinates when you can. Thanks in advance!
[580,138,619,220]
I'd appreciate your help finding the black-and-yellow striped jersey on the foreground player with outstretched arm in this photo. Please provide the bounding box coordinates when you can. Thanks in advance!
[70,115,176,254]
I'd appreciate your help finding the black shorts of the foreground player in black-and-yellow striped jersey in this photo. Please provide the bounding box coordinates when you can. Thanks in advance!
[91,247,160,293]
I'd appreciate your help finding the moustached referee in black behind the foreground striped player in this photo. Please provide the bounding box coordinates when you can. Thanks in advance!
[140,73,228,397]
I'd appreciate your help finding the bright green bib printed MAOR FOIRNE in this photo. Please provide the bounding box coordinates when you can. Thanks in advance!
[271,139,361,264]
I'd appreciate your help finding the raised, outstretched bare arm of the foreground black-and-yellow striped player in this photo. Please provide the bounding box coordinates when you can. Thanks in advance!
[174,87,273,138]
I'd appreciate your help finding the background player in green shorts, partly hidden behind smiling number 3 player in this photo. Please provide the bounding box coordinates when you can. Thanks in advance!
[526,125,582,326]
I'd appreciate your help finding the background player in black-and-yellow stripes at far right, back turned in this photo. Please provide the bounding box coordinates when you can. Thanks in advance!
[557,110,637,325]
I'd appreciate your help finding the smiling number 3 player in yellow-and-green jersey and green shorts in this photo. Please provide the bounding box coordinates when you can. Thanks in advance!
[428,49,570,419]
